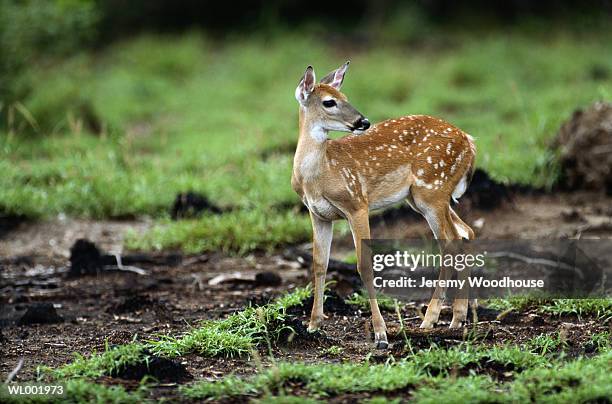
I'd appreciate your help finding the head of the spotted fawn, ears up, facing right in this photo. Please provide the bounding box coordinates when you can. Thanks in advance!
[295,62,370,139]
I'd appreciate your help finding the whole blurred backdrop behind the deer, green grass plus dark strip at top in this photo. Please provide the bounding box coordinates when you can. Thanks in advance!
[0,0,612,252]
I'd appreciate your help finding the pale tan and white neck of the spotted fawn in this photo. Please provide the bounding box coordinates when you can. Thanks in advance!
[293,109,327,181]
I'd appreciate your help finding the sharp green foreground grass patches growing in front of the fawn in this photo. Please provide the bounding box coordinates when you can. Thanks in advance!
[26,288,612,403]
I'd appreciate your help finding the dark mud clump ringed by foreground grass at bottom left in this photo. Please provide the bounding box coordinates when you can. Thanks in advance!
[110,356,193,383]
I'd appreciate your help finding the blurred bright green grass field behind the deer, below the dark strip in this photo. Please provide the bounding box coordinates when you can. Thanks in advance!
[0,29,612,252]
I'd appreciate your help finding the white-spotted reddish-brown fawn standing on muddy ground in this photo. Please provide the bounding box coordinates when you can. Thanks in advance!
[291,61,476,349]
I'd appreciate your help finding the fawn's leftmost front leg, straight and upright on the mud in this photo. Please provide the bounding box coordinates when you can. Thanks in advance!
[308,212,333,332]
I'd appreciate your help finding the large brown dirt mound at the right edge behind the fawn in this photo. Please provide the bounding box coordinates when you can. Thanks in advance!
[553,102,612,195]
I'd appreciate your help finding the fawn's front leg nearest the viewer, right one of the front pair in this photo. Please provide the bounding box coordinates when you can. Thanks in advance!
[348,209,389,349]
